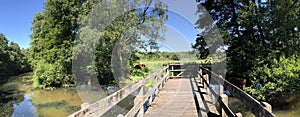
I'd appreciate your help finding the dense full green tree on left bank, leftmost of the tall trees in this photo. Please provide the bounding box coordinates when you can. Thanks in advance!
[30,0,83,88]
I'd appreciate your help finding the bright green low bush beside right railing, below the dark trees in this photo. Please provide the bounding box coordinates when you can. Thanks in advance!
[245,56,300,101]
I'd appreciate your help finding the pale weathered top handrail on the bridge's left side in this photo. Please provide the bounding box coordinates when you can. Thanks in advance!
[69,66,169,117]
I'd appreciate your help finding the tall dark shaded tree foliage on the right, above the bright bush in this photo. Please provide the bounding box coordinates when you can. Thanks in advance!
[197,0,300,77]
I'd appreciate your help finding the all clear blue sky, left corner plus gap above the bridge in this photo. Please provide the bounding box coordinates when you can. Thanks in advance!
[0,0,202,51]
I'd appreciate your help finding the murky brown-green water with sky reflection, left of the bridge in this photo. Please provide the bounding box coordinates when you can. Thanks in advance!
[0,73,82,117]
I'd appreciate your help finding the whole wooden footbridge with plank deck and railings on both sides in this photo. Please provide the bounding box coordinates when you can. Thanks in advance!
[69,64,275,117]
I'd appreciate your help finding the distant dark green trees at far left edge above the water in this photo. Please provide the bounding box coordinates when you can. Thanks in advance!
[0,33,31,77]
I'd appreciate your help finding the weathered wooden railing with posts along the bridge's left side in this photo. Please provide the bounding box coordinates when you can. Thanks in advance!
[69,65,169,117]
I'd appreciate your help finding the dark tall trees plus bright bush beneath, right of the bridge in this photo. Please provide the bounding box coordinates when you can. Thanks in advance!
[195,0,300,101]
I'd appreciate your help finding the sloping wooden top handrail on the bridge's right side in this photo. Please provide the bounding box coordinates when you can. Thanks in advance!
[199,66,275,117]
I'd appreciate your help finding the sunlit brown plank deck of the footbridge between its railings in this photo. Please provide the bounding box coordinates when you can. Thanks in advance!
[144,78,216,117]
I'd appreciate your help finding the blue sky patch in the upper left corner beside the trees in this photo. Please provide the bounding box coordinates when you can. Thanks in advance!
[0,0,45,48]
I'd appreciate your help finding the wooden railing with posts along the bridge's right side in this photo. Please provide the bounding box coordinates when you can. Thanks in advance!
[198,66,275,117]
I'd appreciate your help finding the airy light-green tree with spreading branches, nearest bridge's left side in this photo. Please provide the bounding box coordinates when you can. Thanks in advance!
[74,0,167,83]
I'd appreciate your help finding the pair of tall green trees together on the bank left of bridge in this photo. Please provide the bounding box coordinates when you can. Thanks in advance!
[29,0,166,88]
